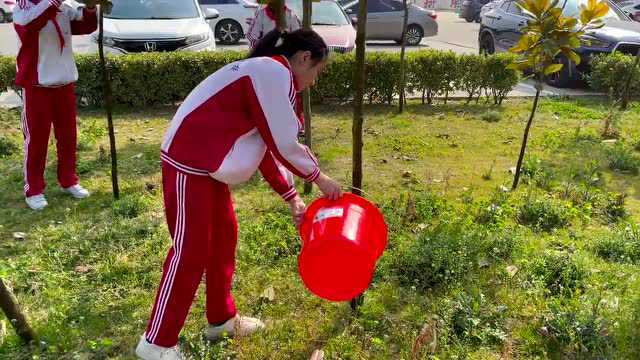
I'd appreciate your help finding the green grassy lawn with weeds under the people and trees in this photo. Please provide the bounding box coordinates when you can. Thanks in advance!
[0,99,640,359]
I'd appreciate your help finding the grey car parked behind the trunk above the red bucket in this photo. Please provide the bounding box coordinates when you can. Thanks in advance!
[344,0,438,46]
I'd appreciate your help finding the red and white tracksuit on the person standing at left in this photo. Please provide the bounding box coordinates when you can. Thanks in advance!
[13,0,98,196]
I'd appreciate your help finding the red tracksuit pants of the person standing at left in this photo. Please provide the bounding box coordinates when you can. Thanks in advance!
[22,84,78,197]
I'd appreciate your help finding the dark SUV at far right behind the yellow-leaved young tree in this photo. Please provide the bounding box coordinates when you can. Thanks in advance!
[478,0,640,87]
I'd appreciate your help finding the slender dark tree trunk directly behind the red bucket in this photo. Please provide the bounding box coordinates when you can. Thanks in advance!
[351,0,367,310]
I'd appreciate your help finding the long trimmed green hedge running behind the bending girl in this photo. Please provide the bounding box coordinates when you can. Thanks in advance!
[0,50,520,106]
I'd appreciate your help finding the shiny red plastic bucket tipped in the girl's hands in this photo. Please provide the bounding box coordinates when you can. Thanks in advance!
[298,193,388,301]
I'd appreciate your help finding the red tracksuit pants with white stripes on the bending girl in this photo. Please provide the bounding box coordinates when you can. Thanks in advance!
[145,162,238,347]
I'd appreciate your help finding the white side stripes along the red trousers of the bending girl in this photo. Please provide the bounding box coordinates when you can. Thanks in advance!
[149,172,184,342]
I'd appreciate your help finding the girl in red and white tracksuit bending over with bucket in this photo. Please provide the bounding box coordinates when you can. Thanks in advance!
[136,30,341,359]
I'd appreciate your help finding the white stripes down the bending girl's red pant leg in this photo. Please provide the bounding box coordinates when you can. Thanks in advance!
[149,173,187,343]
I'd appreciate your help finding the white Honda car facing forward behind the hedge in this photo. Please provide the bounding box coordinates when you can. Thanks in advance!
[91,0,220,54]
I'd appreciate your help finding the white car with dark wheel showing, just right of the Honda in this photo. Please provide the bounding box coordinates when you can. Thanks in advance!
[200,0,258,45]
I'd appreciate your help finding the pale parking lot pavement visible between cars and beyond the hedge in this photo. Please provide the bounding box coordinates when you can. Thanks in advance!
[0,11,594,106]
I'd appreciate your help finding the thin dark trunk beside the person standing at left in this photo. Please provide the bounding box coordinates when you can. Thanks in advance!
[98,7,120,199]
